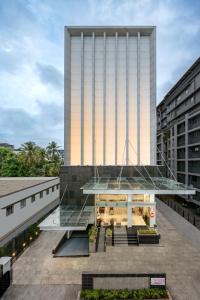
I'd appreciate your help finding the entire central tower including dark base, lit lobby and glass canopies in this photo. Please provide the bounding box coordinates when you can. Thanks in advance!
[40,26,195,244]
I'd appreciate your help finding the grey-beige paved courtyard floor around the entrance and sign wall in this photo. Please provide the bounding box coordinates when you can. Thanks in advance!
[3,204,200,300]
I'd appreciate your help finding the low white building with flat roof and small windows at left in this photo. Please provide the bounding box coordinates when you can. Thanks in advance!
[0,177,60,252]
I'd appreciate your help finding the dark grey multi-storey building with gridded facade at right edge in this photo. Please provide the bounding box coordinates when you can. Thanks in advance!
[157,58,200,205]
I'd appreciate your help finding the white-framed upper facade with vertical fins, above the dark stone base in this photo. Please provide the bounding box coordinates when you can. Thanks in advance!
[64,26,156,165]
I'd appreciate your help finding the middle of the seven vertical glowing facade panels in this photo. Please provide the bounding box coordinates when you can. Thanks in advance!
[106,36,115,165]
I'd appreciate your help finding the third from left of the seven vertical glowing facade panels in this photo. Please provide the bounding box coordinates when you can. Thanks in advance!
[95,37,104,165]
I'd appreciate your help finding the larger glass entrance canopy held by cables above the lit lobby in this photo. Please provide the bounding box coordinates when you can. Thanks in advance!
[81,177,196,195]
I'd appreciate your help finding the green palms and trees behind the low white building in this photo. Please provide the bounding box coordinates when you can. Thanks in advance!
[0,141,63,177]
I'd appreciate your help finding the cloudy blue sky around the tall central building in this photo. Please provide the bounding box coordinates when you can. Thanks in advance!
[0,0,200,148]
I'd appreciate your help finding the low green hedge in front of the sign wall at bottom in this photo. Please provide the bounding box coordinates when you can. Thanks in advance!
[81,288,169,300]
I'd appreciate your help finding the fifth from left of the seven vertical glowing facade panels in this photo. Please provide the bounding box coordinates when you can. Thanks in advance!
[117,36,126,165]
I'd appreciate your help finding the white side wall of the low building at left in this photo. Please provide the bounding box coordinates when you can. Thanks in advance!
[0,178,60,246]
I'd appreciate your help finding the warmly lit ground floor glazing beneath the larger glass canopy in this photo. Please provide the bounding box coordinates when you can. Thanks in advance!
[95,194,156,227]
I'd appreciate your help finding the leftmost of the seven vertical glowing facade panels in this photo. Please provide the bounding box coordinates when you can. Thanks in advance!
[71,37,81,165]
